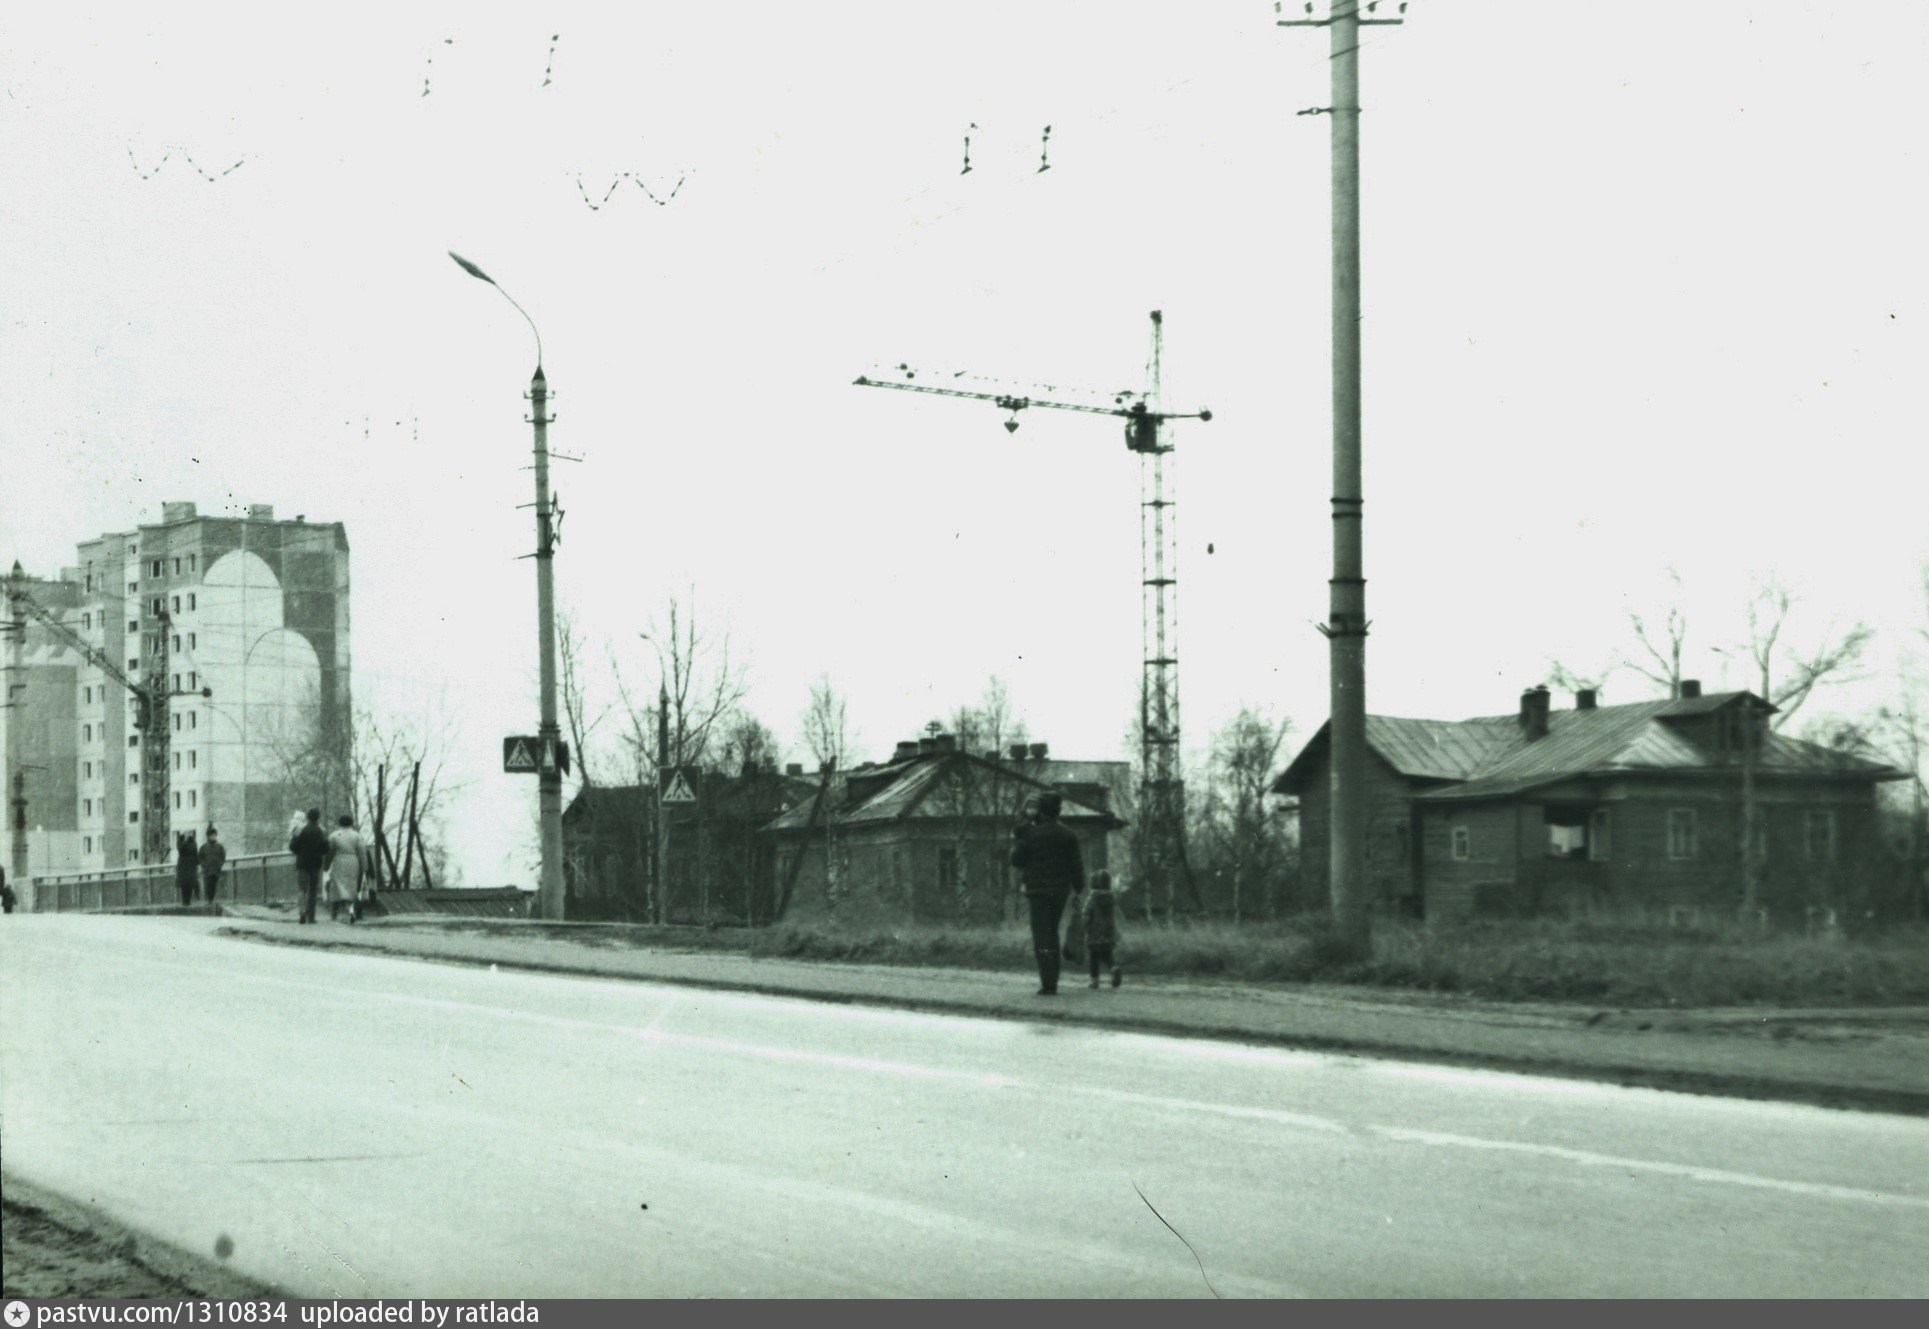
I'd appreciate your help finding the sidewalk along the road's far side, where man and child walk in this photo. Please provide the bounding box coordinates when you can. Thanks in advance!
[211,907,1929,1115]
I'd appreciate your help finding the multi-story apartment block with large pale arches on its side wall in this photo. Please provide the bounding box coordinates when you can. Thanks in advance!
[13,503,351,870]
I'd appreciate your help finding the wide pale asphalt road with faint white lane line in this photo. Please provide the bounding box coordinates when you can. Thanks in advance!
[0,914,1929,1296]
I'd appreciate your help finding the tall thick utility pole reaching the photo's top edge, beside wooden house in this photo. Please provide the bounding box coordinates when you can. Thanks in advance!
[1279,0,1406,949]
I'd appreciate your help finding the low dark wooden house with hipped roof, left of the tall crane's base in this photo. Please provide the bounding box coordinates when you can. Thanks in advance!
[764,735,1125,924]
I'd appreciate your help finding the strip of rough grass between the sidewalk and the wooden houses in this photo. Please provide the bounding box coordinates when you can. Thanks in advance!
[443,920,1929,1007]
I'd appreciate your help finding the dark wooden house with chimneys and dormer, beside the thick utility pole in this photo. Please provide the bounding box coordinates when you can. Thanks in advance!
[1273,681,1902,918]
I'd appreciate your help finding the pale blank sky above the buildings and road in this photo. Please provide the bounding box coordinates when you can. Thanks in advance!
[0,0,1929,885]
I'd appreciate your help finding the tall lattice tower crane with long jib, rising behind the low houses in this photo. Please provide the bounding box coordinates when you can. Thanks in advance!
[856,309,1211,909]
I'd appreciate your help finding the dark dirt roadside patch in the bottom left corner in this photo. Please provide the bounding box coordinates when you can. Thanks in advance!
[0,1177,274,1302]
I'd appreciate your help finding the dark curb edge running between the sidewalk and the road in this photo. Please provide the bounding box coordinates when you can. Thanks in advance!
[215,928,1929,1117]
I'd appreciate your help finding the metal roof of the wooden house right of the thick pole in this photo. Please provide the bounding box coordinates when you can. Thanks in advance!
[1273,692,1900,800]
